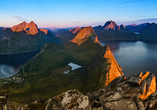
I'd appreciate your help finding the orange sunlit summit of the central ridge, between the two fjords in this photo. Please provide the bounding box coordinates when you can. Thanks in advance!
[71,26,99,45]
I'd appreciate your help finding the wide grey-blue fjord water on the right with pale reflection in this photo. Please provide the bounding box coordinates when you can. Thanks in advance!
[100,41,157,77]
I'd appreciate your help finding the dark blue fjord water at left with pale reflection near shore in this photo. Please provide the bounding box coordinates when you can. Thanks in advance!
[0,51,39,79]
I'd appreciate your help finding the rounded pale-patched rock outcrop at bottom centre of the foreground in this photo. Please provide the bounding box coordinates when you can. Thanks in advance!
[45,90,91,110]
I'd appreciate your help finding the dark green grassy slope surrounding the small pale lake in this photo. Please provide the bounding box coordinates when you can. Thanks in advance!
[0,41,107,103]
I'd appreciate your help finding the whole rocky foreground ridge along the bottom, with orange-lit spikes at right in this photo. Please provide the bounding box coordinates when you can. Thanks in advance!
[0,72,157,110]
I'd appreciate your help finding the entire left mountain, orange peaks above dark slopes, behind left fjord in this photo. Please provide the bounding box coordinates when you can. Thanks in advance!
[0,21,61,54]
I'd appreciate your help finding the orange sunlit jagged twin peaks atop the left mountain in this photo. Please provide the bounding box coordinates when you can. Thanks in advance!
[11,21,38,35]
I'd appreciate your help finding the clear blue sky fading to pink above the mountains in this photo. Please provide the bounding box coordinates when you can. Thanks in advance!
[0,0,157,28]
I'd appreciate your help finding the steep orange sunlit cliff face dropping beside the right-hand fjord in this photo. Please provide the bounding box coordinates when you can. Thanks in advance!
[104,46,124,86]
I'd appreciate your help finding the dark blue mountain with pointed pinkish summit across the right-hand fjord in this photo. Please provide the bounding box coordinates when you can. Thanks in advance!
[93,21,138,41]
